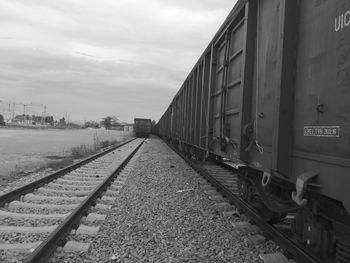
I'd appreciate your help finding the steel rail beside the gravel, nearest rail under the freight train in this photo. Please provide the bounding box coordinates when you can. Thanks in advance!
[169,145,321,263]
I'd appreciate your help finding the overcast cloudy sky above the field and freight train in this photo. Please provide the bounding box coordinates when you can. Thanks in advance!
[0,0,236,123]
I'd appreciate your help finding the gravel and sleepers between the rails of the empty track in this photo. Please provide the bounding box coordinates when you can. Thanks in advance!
[0,140,144,262]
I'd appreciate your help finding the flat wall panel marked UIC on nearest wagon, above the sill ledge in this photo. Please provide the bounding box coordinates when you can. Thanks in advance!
[294,0,350,159]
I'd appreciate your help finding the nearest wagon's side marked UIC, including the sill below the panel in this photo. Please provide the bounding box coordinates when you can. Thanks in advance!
[292,0,350,206]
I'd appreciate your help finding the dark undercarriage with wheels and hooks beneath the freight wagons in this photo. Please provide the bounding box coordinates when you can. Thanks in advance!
[170,138,350,263]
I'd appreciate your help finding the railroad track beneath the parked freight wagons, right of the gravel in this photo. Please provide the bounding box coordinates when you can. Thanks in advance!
[170,145,322,263]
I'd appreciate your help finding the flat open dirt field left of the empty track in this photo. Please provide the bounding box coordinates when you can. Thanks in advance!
[0,129,131,187]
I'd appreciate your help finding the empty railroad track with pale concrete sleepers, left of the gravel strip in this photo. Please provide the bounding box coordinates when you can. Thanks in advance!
[0,139,144,263]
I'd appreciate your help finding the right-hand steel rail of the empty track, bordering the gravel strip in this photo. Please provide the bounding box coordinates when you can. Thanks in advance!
[24,140,144,263]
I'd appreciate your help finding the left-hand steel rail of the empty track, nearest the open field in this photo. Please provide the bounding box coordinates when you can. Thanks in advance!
[0,138,136,207]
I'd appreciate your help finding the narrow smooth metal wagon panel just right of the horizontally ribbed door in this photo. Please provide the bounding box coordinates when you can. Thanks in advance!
[246,0,284,172]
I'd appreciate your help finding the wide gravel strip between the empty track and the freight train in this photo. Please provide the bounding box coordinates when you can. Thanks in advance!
[51,139,277,263]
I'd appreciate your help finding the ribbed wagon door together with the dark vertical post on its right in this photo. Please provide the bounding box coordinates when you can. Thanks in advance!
[211,3,256,162]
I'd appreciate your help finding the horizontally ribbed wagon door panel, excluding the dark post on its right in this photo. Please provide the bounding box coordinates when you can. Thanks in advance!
[213,10,246,158]
